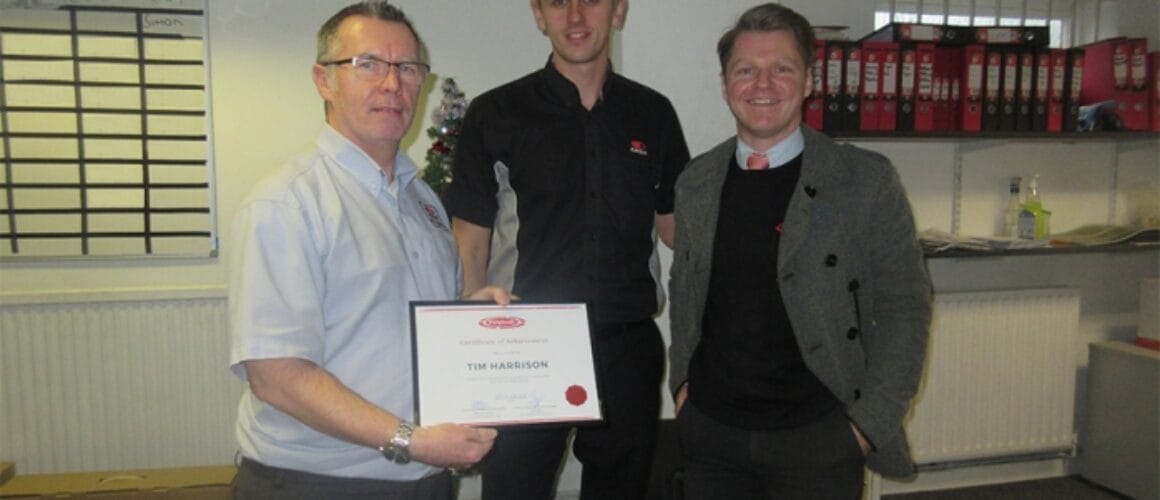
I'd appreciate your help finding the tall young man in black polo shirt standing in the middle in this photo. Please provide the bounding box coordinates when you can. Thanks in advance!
[447,0,689,500]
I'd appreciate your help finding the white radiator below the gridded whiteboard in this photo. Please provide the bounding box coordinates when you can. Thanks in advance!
[0,297,241,473]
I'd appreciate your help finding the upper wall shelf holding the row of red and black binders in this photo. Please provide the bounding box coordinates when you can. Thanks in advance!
[825,131,1160,143]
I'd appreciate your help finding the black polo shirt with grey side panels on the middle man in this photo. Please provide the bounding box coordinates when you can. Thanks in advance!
[445,60,689,323]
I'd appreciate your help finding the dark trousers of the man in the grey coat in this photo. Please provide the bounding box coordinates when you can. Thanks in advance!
[676,403,865,500]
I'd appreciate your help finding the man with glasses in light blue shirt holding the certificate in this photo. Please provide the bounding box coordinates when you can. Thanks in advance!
[229,1,509,500]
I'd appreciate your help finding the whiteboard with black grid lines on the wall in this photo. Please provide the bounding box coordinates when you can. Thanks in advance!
[0,0,217,260]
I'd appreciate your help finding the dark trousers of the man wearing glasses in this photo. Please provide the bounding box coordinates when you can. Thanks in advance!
[233,458,455,500]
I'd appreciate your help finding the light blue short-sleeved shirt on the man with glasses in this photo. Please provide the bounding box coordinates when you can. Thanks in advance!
[227,126,459,480]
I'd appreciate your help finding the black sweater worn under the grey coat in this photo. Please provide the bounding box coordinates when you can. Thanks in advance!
[689,155,839,430]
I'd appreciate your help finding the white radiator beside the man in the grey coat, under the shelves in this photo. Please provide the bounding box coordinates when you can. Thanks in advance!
[906,289,1080,468]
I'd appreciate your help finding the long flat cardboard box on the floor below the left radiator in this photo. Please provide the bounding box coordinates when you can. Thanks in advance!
[0,465,237,500]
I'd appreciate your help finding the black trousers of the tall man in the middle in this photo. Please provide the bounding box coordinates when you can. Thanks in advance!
[480,320,665,500]
